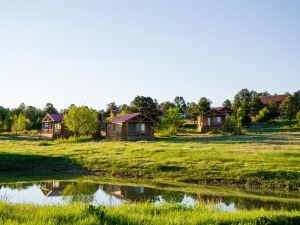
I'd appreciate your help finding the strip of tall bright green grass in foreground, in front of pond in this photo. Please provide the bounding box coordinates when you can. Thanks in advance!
[0,203,300,225]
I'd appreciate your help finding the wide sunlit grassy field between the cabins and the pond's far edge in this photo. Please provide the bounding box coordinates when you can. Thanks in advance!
[0,132,300,190]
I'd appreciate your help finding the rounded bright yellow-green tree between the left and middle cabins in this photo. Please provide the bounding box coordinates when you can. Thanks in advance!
[64,106,98,136]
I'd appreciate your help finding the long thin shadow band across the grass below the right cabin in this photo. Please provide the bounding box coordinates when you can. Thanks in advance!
[157,133,300,145]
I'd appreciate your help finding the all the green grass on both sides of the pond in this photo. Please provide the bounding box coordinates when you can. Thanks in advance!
[0,129,300,224]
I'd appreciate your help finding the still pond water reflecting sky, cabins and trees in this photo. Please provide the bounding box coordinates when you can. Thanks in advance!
[0,181,300,211]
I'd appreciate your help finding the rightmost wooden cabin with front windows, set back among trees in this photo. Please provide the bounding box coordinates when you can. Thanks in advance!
[197,106,232,132]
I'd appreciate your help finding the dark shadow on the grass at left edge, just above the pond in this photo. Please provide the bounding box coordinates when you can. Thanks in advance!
[0,152,82,172]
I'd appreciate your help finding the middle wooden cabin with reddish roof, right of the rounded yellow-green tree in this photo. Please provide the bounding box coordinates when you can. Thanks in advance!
[106,113,154,141]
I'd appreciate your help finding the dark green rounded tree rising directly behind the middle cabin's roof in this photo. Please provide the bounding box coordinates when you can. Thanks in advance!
[130,96,159,118]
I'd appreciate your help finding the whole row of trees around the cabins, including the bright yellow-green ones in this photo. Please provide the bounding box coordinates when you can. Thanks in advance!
[0,89,300,133]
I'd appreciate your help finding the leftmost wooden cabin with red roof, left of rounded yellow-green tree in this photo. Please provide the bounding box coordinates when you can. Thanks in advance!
[41,114,73,138]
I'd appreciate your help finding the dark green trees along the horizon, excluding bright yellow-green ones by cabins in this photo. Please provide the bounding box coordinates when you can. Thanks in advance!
[0,88,300,132]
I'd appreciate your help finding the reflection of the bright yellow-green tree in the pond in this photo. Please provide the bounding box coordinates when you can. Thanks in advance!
[62,183,99,203]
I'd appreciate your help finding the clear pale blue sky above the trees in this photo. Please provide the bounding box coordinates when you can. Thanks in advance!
[0,0,300,109]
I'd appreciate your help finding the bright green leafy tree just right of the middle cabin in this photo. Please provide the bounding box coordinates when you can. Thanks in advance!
[157,108,184,134]
